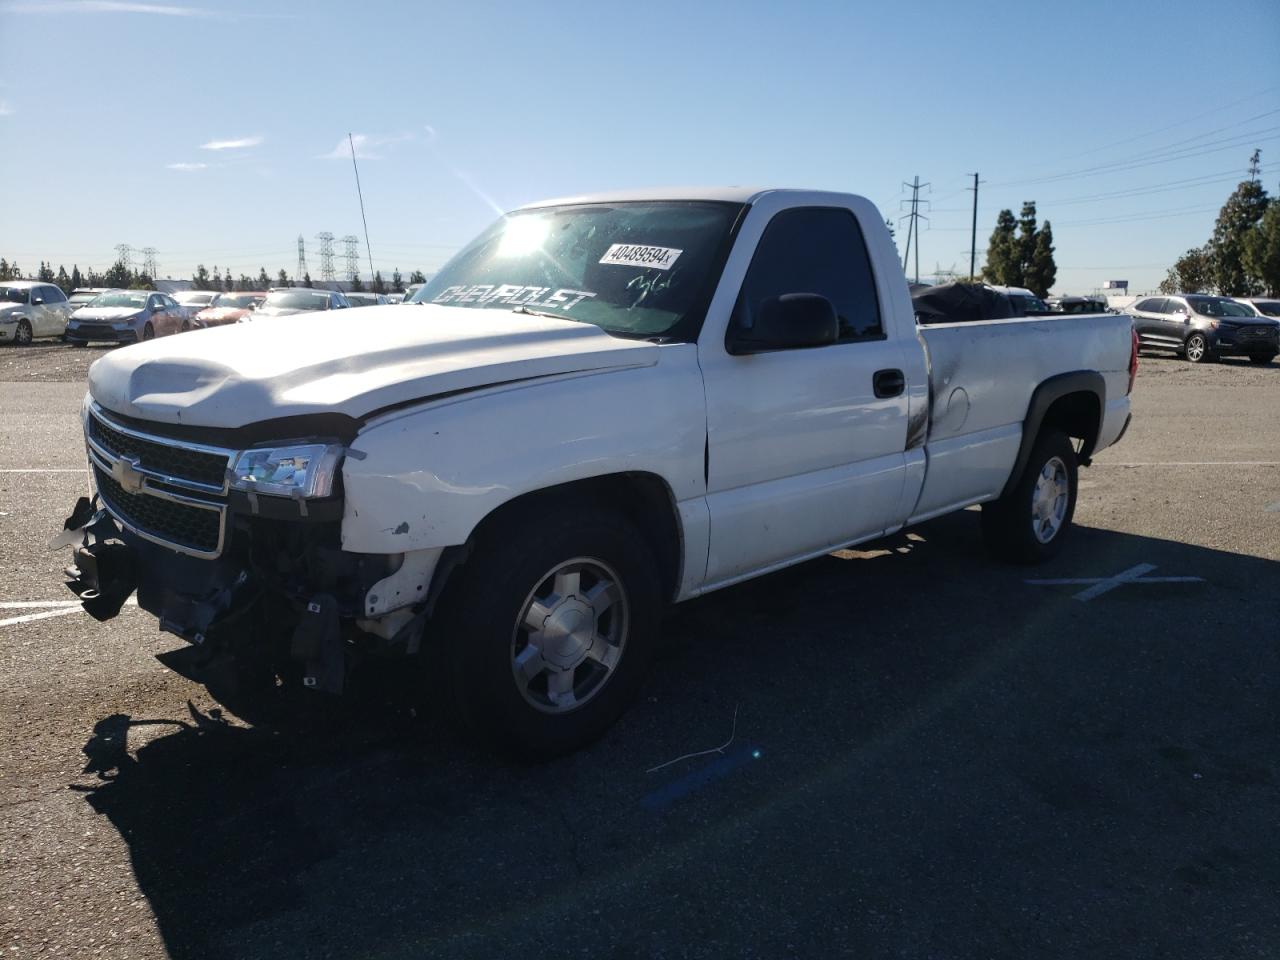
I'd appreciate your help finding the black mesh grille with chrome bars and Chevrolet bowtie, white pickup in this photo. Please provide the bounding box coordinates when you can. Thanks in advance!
[86,403,234,559]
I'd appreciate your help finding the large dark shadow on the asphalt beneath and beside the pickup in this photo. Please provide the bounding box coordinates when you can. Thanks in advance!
[73,513,1280,957]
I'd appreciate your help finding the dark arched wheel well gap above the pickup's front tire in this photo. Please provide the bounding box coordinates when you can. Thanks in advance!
[431,472,684,599]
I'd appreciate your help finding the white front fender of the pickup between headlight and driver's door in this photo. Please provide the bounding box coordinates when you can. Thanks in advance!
[342,344,707,553]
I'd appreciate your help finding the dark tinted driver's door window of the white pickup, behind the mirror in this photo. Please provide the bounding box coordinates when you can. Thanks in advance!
[733,207,884,342]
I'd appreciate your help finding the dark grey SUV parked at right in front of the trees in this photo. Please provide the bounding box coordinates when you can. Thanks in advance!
[1125,293,1280,364]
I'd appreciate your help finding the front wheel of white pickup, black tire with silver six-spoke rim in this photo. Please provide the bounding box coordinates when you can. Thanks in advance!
[437,502,662,760]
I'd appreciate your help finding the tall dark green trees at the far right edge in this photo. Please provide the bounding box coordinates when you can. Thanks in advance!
[1160,150,1280,297]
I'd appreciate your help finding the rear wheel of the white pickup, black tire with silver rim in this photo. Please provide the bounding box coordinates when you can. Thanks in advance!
[982,429,1078,563]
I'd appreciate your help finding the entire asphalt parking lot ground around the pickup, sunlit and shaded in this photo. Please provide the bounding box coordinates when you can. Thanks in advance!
[0,344,1280,960]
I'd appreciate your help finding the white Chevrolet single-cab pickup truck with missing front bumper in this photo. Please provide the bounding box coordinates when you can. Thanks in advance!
[55,189,1137,756]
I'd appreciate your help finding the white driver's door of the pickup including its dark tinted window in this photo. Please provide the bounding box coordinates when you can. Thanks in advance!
[699,207,908,586]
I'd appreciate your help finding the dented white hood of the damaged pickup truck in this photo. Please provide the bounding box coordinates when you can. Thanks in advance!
[88,303,658,428]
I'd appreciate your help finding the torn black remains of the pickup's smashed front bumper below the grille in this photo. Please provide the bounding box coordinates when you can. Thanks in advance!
[50,497,438,694]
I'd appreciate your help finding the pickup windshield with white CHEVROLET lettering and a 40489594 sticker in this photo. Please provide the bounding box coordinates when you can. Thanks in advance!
[411,201,741,338]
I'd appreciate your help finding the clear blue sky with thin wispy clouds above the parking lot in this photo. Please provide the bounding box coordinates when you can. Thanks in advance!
[0,0,1280,293]
